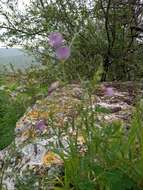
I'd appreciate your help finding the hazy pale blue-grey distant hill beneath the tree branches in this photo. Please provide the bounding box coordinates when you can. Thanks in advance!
[0,48,39,71]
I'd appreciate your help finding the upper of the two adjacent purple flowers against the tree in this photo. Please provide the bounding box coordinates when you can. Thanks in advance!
[49,32,64,48]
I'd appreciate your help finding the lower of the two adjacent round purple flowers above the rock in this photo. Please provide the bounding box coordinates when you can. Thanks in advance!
[56,46,71,60]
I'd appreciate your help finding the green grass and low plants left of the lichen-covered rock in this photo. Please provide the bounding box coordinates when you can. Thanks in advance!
[0,68,49,149]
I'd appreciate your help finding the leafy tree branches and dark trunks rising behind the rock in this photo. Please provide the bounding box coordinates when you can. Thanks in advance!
[0,0,143,80]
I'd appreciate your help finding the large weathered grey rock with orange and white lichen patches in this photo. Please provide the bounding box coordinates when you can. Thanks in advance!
[0,83,142,190]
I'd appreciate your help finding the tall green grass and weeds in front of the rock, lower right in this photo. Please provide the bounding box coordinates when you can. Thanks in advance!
[53,100,143,190]
